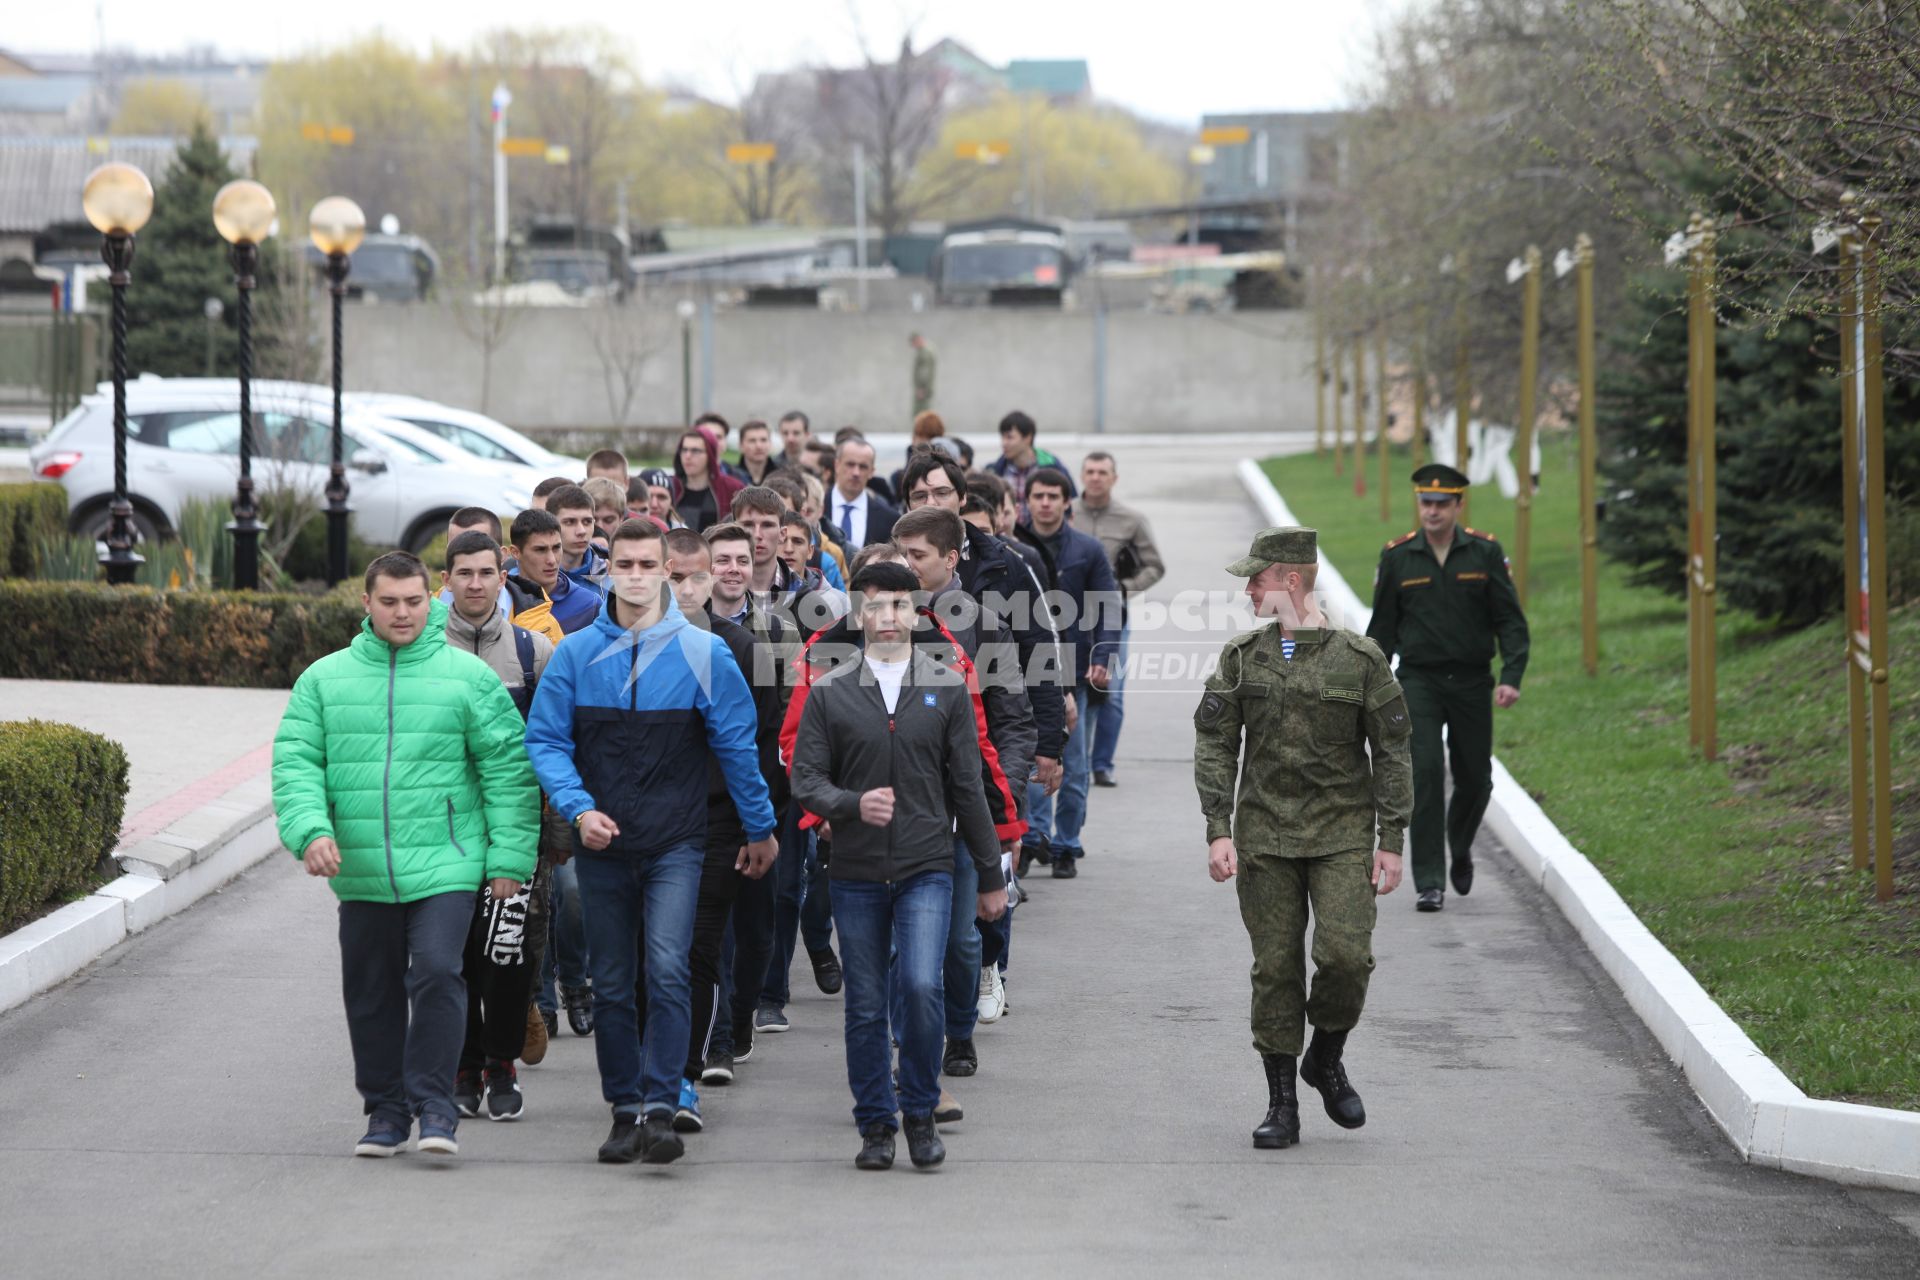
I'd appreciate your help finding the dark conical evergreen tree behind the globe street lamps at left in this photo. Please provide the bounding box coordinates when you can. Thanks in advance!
[127,123,257,378]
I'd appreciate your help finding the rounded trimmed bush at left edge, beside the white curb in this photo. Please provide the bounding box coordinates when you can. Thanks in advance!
[0,720,127,933]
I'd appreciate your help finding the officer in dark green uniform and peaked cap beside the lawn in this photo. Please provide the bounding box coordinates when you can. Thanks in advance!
[1367,462,1526,912]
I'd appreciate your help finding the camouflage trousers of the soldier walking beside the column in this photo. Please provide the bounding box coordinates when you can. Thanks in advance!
[1235,848,1377,1057]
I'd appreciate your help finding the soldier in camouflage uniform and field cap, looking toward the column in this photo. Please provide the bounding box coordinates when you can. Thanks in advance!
[1194,528,1413,1148]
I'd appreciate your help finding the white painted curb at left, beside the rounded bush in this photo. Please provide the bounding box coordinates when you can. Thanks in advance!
[0,781,280,1013]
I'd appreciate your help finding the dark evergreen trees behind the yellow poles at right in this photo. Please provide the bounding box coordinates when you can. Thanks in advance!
[1597,260,1920,626]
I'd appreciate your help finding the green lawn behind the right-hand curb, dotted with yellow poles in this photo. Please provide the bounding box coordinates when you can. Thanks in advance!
[1265,439,1920,1109]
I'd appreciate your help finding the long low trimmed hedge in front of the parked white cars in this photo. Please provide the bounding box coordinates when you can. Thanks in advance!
[0,580,365,689]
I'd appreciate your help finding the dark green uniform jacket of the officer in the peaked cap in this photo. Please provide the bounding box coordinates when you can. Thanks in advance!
[1367,526,1528,689]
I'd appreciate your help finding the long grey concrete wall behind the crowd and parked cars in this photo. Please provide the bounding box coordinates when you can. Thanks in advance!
[346,305,1313,438]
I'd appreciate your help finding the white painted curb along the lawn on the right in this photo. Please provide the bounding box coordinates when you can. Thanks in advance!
[1238,459,1920,1192]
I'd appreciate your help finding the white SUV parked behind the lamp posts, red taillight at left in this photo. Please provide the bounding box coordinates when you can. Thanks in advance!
[29,378,543,551]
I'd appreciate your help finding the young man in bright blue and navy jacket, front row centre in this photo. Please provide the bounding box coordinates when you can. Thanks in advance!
[526,520,778,1165]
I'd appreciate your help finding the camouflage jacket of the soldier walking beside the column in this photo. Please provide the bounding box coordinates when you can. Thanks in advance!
[1194,626,1413,858]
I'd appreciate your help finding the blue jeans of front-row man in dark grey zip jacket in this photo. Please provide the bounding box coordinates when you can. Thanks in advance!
[833,871,954,1128]
